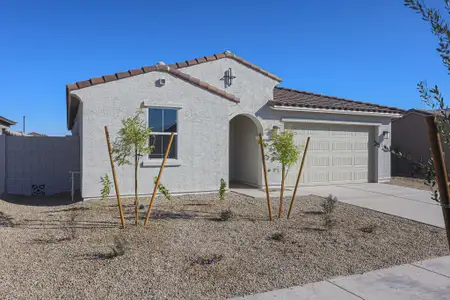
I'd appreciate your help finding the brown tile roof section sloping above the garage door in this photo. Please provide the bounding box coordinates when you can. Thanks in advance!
[270,87,405,114]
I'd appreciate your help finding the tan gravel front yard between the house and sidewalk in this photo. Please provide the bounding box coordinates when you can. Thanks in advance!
[0,193,448,299]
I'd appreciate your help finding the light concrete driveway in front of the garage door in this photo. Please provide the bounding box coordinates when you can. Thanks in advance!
[231,183,444,227]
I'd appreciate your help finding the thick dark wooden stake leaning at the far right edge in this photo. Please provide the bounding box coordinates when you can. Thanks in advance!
[426,116,450,248]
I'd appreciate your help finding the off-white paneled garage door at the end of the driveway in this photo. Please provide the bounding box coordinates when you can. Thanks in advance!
[285,123,372,186]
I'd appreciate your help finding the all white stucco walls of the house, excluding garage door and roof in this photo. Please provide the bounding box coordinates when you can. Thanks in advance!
[72,58,390,198]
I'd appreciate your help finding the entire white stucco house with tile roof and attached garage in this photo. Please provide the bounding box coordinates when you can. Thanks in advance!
[66,51,403,198]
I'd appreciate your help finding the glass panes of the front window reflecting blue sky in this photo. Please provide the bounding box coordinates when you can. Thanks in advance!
[148,108,178,159]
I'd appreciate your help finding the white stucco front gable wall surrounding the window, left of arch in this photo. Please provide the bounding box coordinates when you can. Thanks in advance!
[74,72,229,198]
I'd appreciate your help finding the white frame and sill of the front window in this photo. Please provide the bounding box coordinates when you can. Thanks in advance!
[142,105,182,168]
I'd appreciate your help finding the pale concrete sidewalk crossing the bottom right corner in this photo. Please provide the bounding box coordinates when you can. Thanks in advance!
[233,256,450,300]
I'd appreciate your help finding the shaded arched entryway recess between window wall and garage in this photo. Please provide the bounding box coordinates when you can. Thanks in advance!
[229,114,262,187]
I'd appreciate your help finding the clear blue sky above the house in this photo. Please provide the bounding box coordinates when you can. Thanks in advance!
[0,0,450,135]
